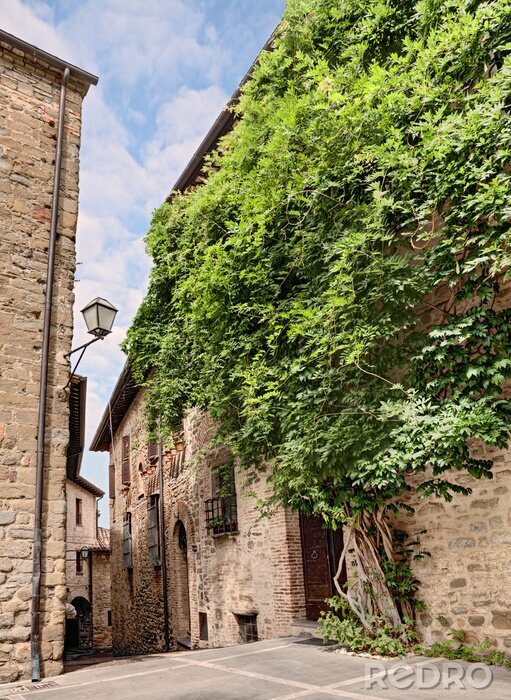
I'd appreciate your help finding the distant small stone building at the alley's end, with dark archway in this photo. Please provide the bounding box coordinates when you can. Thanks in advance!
[65,376,112,652]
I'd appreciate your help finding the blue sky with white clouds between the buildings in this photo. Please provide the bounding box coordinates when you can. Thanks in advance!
[0,0,285,525]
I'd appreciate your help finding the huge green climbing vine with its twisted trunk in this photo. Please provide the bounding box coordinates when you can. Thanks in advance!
[125,0,511,630]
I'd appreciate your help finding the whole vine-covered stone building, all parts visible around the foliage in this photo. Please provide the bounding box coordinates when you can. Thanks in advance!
[92,31,511,653]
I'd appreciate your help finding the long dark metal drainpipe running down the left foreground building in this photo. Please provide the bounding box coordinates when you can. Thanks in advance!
[30,68,70,683]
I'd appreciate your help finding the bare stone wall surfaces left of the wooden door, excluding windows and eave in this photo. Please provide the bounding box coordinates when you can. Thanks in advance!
[111,391,305,654]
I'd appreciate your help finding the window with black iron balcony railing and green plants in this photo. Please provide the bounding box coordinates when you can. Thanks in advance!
[205,463,238,535]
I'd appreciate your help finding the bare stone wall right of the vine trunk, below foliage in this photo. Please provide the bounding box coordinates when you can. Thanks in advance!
[396,450,511,653]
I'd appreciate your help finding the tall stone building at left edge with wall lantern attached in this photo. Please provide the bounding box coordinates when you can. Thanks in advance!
[0,31,97,682]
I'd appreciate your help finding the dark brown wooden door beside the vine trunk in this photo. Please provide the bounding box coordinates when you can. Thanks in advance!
[300,515,344,620]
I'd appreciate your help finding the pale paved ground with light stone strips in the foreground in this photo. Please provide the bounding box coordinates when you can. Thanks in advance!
[0,638,511,700]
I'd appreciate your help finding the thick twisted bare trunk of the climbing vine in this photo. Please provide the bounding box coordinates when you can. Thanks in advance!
[334,510,408,633]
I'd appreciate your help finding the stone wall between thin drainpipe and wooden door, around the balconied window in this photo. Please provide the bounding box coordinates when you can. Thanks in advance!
[174,411,305,646]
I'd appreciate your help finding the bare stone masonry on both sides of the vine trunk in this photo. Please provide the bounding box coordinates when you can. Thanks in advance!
[104,382,511,654]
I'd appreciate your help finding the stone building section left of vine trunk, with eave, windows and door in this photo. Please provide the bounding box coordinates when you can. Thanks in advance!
[92,368,342,654]
